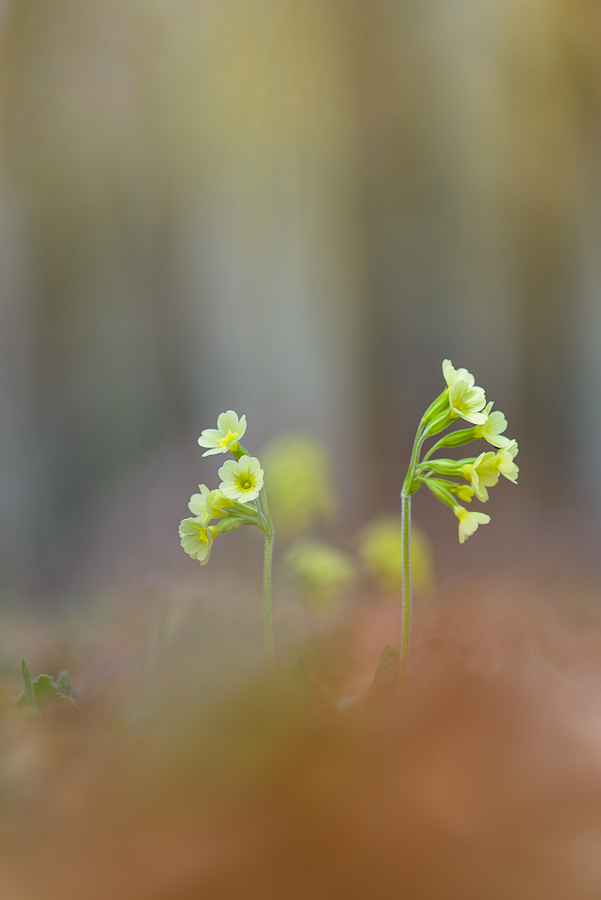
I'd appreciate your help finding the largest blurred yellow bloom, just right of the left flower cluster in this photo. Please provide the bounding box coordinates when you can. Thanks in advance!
[261,434,337,536]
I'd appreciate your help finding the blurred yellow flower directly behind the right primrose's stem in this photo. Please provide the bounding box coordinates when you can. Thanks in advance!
[359,516,432,593]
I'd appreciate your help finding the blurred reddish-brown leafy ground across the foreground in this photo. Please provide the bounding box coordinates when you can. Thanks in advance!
[0,600,601,900]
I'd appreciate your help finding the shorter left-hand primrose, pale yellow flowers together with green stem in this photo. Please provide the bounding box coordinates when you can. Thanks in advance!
[179,409,276,701]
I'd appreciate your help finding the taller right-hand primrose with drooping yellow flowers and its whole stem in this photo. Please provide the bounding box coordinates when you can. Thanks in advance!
[399,359,519,687]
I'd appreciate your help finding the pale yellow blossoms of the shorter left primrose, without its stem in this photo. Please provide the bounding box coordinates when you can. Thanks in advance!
[179,409,263,565]
